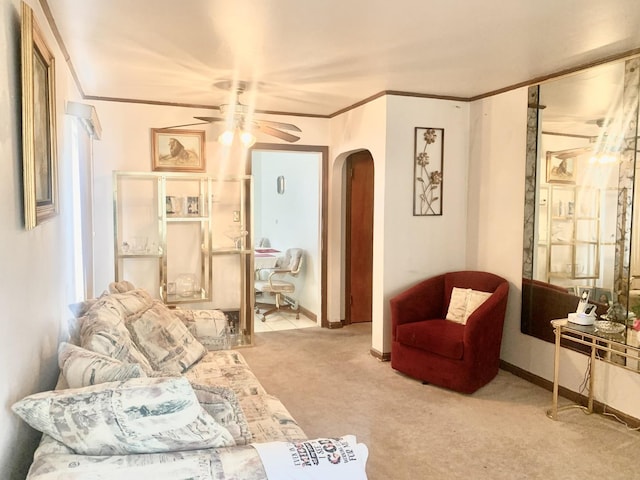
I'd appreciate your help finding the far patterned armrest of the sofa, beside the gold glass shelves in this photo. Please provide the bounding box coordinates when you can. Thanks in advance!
[173,309,230,351]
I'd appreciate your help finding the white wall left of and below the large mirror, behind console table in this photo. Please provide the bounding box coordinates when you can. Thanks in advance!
[467,88,640,418]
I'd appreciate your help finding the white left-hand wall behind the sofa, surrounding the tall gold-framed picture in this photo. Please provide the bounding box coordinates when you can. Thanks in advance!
[0,0,84,479]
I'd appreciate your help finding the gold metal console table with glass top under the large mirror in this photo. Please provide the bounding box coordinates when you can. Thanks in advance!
[547,318,640,420]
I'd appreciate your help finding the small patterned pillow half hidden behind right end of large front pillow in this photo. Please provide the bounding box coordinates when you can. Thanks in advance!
[191,384,252,445]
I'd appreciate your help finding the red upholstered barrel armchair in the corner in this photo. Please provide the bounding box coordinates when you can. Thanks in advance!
[391,271,509,393]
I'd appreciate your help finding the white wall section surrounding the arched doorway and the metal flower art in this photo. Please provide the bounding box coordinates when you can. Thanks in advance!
[329,96,469,353]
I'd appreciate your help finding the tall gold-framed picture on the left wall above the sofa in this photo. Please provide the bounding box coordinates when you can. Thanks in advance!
[20,2,58,230]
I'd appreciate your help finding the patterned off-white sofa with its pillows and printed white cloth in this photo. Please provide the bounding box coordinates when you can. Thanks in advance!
[13,282,367,480]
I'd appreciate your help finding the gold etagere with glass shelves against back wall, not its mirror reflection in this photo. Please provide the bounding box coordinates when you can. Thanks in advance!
[113,171,253,345]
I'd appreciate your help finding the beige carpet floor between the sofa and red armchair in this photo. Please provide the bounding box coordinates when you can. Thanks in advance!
[242,324,640,480]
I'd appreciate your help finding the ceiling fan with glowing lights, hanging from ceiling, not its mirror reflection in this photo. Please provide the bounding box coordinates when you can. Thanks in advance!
[167,80,302,144]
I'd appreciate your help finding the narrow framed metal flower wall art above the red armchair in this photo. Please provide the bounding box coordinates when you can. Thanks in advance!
[413,127,444,216]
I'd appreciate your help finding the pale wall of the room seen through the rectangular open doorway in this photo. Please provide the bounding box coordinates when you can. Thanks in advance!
[252,150,322,316]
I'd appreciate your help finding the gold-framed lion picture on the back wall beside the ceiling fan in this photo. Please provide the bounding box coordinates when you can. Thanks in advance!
[151,128,206,172]
